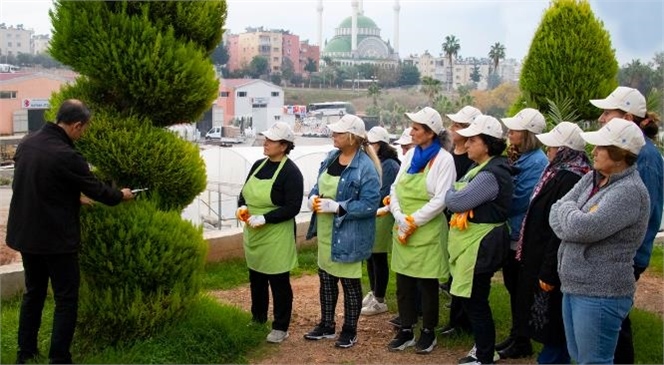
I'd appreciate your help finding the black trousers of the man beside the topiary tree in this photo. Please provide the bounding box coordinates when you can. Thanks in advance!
[17,252,81,364]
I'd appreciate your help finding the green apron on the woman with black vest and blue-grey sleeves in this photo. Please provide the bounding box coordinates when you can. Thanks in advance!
[448,159,503,298]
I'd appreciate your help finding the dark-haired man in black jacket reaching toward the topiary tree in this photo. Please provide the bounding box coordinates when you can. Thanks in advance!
[7,99,134,364]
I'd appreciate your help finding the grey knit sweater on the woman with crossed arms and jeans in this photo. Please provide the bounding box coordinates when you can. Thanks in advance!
[549,165,650,297]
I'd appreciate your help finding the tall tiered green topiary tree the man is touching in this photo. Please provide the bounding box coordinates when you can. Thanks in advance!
[47,0,226,342]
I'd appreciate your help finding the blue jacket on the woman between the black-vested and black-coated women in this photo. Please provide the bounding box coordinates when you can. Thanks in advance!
[508,148,549,241]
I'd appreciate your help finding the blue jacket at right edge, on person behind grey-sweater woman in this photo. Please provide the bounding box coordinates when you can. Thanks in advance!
[634,138,664,269]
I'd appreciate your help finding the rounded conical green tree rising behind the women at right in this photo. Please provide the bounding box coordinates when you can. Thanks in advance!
[514,0,618,120]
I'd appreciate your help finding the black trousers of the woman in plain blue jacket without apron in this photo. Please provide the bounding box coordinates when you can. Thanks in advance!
[503,246,529,341]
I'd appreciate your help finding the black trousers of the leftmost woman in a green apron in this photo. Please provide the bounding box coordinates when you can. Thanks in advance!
[249,269,293,331]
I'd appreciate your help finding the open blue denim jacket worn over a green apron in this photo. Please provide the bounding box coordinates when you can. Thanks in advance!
[307,150,381,262]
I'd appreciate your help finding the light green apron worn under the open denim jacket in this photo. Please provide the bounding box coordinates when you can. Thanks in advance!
[316,170,362,279]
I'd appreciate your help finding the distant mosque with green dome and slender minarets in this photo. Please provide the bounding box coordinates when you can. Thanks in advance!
[316,0,401,68]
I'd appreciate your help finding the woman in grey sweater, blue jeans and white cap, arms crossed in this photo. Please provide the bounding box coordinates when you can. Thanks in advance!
[549,118,650,364]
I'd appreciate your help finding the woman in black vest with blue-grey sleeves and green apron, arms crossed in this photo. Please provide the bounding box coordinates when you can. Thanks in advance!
[445,115,512,364]
